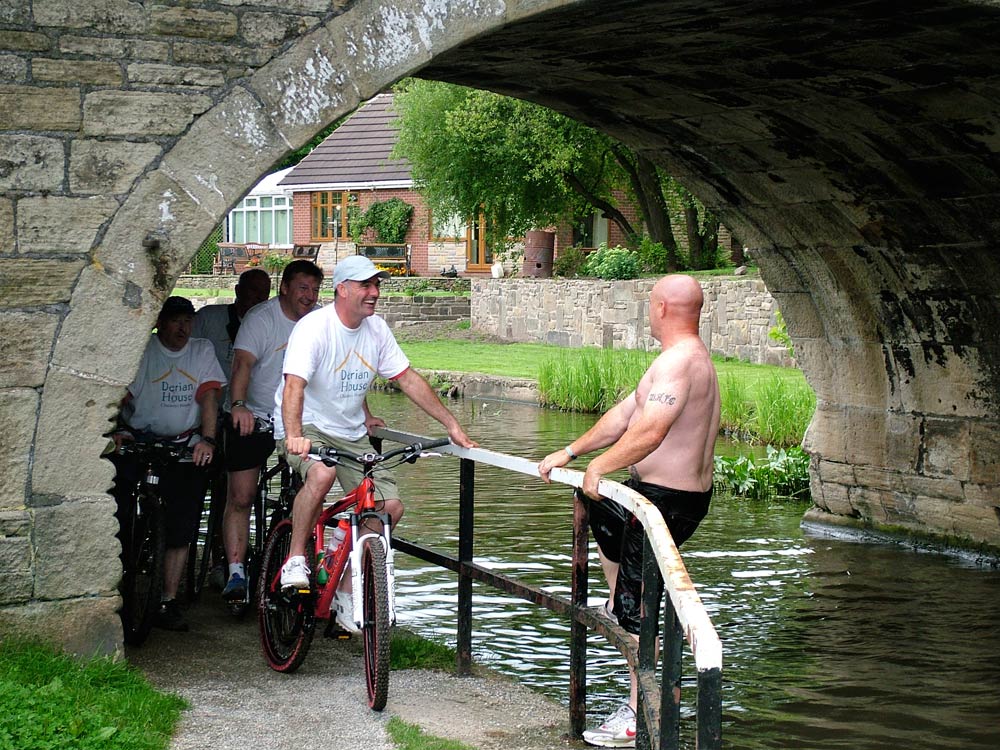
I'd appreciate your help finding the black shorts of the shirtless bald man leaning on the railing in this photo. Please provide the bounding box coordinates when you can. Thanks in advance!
[587,479,712,635]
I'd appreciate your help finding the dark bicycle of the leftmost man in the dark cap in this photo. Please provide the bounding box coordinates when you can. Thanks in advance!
[115,440,191,646]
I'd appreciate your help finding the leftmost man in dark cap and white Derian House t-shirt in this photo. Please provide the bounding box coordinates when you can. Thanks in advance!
[112,297,226,630]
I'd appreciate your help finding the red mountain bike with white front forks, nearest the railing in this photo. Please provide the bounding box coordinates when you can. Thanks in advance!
[257,438,450,711]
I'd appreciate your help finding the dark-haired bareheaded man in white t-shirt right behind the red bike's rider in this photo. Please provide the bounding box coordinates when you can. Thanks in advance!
[222,260,323,603]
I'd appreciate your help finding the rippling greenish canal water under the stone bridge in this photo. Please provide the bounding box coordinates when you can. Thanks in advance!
[370,394,1000,750]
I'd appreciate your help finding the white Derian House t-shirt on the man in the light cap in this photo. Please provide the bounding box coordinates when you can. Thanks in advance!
[274,305,410,440]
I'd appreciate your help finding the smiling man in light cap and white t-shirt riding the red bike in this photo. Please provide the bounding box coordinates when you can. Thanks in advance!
[275,255,476,630]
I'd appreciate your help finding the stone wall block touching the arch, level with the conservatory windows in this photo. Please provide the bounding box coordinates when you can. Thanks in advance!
[17,196,118,255]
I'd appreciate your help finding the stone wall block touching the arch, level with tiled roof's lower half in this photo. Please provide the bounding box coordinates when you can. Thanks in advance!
[69,139,161,196]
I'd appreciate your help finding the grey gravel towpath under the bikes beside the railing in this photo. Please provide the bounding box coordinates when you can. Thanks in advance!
[127,591,585,750]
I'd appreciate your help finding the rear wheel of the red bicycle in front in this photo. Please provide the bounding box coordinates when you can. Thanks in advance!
[257,519,315,672]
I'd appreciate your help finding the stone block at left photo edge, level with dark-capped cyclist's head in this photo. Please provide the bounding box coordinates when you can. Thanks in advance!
[0,310,61,388]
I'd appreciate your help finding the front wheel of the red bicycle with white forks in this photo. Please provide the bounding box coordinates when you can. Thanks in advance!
[361,539,391,711]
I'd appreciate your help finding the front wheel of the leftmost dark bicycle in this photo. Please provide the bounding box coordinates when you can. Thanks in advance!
[119,494,166,646]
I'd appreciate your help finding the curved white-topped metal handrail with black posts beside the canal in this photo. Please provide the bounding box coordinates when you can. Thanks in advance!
[374,428,722,749]
